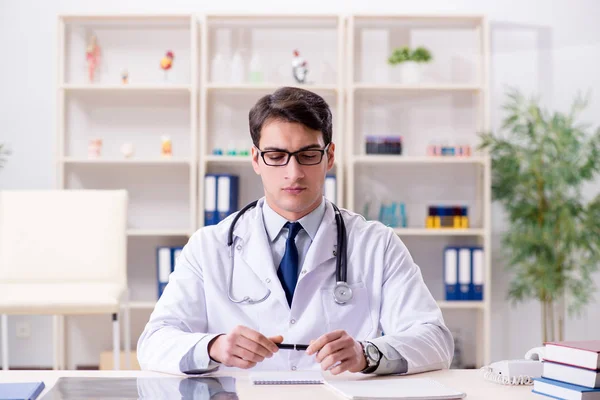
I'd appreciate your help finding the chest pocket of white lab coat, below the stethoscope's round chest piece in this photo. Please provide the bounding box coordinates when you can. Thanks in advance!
[321,282,373,340]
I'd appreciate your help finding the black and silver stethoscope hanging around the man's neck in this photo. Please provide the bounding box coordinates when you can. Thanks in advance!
[227,200,352,304]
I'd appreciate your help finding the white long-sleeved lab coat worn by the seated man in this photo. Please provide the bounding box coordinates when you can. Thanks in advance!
[138,198,454,373]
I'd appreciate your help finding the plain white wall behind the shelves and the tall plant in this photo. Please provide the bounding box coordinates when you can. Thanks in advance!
[0,0,600,368]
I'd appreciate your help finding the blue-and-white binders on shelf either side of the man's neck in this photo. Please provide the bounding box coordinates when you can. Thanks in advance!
[204,174,337,225]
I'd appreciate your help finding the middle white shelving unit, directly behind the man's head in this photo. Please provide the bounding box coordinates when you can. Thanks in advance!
[198,14,344,226]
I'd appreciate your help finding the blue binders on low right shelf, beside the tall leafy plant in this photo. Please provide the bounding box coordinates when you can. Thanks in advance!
[444,246,484,300]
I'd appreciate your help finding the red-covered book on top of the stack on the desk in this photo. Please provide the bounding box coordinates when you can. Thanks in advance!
[544,340,600,371]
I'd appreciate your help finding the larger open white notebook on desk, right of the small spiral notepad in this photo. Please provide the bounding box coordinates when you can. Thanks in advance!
[325,378,466,400]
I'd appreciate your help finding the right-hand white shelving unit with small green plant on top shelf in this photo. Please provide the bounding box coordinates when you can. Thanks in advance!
[346,15,491,366]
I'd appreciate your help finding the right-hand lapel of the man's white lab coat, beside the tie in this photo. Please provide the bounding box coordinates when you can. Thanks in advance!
[302,202,337,275]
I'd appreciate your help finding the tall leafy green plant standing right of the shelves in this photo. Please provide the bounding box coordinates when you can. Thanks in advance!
[479,90,600,342]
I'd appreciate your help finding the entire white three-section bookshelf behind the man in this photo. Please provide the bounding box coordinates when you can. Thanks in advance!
[56,14,491,366]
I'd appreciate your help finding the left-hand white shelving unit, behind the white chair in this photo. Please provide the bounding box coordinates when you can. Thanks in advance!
[56,14,199,364]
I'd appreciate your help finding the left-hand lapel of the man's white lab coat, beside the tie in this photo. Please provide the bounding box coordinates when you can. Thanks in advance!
[234,200,289,309]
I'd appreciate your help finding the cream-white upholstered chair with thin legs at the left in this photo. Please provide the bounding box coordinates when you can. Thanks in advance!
[0,190,129,369]
